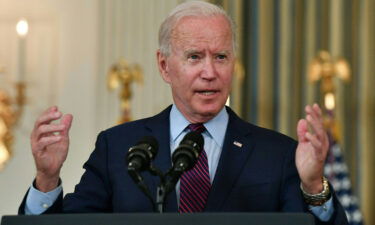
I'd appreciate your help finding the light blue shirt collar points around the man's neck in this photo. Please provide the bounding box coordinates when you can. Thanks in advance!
[169,104,229,147]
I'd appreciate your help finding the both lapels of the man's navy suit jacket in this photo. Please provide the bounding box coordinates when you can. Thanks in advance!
[141,106,254,212]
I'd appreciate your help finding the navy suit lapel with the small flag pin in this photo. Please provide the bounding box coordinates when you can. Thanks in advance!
[205,108,254,212]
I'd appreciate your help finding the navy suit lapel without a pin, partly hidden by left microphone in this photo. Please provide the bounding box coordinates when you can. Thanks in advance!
[146,106,177,212]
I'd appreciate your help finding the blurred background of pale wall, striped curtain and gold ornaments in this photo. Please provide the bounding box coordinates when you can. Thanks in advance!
[0,0,375,224]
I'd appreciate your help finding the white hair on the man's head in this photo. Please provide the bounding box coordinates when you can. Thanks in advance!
[159,1,236,56]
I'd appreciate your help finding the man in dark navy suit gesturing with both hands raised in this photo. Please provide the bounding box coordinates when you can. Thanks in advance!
[20,1,347,224]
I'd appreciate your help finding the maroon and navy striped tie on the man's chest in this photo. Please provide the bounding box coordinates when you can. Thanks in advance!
[178,123,211,213]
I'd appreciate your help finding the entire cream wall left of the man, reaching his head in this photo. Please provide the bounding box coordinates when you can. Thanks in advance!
[0,0,178,216]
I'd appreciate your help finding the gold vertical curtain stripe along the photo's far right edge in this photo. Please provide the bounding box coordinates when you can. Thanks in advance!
[358,0,375,224]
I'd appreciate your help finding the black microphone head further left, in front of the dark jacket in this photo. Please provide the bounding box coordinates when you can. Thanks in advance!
[127,136,158,171]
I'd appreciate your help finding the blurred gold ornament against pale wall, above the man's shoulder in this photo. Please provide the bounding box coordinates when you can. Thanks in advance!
[107,58,143,123]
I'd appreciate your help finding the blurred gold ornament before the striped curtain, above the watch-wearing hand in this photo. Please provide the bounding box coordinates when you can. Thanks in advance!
[308,50,351,140]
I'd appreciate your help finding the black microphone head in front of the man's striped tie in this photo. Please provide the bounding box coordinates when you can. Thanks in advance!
[172,131,204,175]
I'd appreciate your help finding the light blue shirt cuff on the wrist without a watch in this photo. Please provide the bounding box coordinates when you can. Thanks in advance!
[25,181,62,215]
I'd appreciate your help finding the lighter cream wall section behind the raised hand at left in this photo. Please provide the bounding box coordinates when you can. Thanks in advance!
[0,0,98,214]
